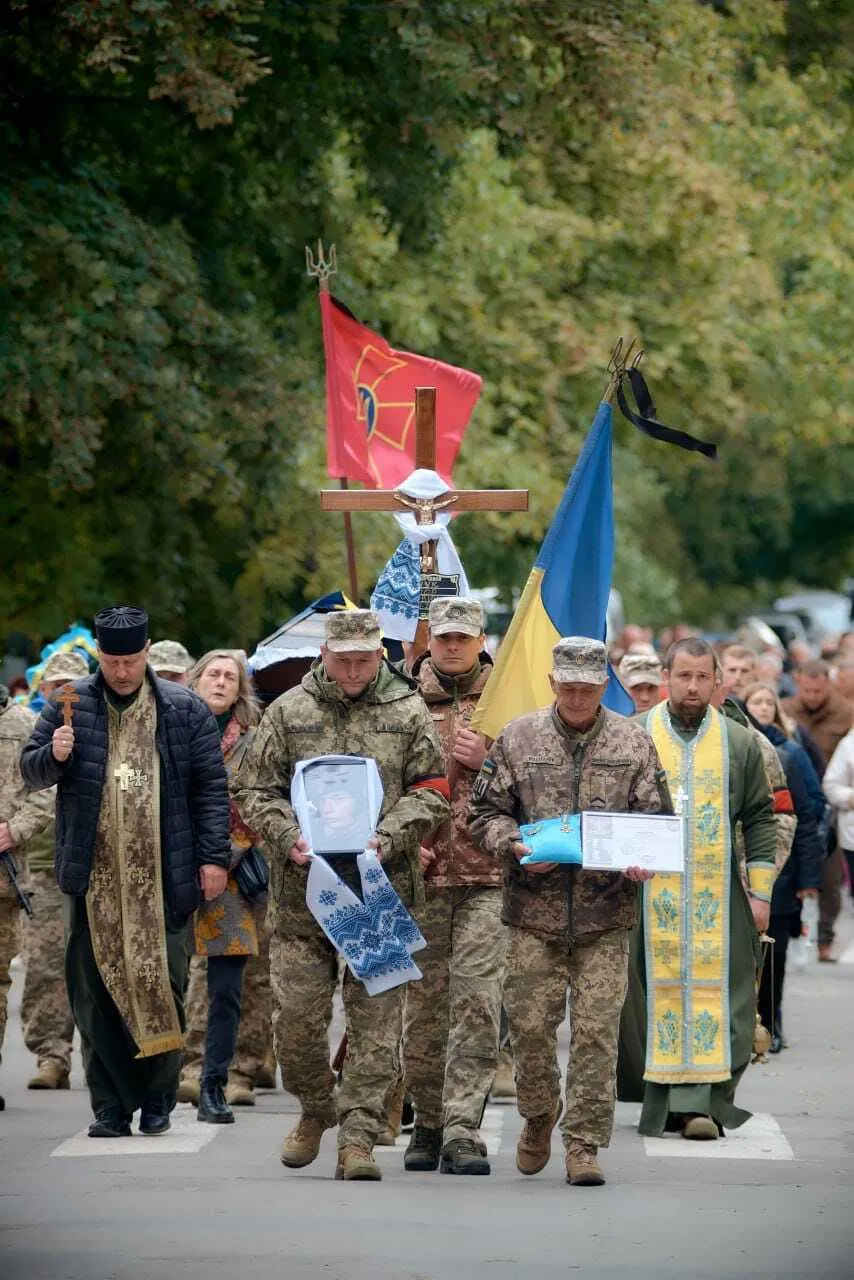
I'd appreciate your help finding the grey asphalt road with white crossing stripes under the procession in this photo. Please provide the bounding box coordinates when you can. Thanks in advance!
[0,904,854,1280]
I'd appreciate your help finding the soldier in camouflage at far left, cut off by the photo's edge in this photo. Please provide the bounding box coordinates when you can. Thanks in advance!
[0,685,54,1111]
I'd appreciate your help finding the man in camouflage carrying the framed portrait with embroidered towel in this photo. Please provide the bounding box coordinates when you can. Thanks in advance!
[233,609,448,1181]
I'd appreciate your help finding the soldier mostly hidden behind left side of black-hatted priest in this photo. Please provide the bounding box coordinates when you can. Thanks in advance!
[20,653,88,1089]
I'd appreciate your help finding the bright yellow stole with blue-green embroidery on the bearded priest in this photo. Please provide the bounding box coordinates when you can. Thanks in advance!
[644,703,732,1084]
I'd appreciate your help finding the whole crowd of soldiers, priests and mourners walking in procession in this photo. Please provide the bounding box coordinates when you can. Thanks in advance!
[0,598,854,1185]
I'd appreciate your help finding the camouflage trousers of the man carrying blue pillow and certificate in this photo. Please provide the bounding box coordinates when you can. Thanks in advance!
[504,928,629,1147]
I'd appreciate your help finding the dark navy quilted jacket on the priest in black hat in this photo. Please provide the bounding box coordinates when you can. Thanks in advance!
[20,668,230,922]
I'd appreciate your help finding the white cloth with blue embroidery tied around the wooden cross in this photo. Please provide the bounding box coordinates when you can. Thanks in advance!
[370,468,469,640]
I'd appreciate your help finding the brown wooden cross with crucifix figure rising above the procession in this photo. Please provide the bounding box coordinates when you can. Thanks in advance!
[320,387,528,617]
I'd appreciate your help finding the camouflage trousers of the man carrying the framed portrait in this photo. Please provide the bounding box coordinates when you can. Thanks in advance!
[270,931,403,1151]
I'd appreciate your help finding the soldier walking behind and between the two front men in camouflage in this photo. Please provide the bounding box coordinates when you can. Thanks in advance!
[403,596,507,1174]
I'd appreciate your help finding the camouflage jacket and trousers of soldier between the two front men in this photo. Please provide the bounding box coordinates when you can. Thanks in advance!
[403,655,507,1143]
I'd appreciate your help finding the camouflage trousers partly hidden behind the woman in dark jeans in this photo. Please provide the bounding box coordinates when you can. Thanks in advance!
[181,909,273,1089]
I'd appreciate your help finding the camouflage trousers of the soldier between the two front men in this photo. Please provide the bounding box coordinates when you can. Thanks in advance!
[403,884,507,1142]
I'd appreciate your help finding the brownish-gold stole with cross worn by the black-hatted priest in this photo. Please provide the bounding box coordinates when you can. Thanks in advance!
[86,680,183,1057]
